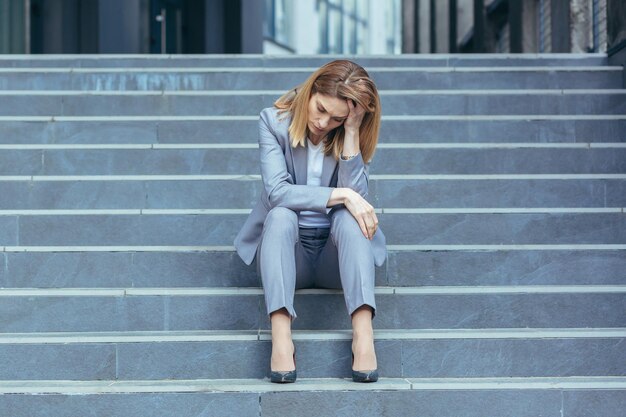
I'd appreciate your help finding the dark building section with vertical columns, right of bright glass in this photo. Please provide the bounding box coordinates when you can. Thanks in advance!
[402,0,608,53]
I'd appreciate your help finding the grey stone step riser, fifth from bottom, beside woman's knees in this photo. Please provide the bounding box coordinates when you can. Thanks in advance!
[0,212,626,245]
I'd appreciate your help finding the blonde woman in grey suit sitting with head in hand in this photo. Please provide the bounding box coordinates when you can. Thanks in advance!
[235,60,386,382]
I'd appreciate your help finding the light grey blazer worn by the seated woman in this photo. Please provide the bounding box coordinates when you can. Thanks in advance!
[235,107,387,266]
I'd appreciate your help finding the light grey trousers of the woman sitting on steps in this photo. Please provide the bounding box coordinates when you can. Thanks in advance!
[256,207,376,319]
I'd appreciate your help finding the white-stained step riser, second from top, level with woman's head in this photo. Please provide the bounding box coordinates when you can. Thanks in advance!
[0,66,622,91]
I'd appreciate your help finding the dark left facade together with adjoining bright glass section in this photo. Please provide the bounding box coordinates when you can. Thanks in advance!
[0,0,402,54]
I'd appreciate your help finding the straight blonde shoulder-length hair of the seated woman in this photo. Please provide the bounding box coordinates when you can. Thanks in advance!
[274,60,381,162]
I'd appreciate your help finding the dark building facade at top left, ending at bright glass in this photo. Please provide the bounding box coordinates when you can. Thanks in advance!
[0,0,264,54]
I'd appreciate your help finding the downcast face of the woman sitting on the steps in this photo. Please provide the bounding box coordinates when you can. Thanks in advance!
[308,93,350,140]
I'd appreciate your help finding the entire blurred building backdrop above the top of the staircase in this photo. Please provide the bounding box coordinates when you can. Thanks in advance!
[0,0,626,54]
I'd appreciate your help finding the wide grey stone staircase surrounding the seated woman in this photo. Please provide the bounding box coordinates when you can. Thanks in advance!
[0,55,626,417]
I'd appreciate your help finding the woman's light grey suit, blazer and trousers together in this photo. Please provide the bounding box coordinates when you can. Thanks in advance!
[235,107,386,318]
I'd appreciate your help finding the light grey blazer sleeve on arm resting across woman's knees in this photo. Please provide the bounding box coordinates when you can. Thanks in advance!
[259,109,333,213]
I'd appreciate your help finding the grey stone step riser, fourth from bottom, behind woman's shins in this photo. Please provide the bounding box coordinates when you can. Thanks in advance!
[0,246,626,288]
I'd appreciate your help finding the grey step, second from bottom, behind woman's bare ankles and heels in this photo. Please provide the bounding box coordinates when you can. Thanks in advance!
[0,328,626,380]
